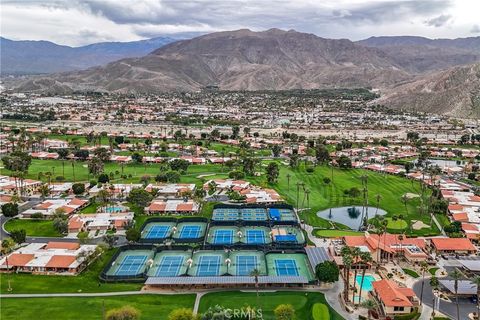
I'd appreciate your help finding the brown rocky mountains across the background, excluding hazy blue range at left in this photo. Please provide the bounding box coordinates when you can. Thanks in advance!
[2,29,480,117]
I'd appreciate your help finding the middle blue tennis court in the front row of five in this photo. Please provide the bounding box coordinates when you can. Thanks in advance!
[188,250,228,277]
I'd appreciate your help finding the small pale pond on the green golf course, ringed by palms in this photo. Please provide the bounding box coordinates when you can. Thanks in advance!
[317,206,387,230]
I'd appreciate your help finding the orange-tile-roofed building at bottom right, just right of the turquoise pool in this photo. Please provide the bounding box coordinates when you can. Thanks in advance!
[371,279,419,318]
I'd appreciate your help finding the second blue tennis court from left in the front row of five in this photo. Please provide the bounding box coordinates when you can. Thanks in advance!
[148,250,192,277]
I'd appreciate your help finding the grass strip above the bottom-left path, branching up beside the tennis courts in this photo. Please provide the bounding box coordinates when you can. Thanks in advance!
[0,250,142,294]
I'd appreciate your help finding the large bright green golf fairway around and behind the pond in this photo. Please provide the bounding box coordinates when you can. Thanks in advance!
[248,163,439,235]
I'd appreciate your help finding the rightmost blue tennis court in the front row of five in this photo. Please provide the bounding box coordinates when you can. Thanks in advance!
[265,253,315,280]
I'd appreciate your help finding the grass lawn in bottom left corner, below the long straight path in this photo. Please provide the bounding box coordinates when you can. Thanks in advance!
[0,294,195,320]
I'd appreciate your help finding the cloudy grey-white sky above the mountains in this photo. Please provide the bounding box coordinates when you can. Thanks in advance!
[0,0,480,46]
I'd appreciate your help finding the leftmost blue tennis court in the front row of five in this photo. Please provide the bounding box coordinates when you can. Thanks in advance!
[107,250,153,277]
